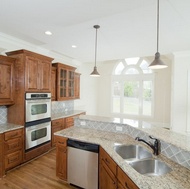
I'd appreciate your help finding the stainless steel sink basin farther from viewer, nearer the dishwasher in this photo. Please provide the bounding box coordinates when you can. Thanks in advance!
[114,145,152,162]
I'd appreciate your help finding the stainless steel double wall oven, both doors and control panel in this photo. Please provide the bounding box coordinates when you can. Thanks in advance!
[25,93,51,151]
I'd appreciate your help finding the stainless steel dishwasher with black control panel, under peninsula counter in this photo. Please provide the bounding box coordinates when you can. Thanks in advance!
[67,139,99,189]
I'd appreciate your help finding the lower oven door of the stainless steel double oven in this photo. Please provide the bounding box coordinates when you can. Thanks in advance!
[25,122,51,150]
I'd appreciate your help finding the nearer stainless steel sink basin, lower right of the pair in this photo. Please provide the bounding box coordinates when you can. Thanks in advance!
[129,159,172,176]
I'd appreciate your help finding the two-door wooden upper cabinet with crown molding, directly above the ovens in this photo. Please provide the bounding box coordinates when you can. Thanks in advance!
[6,50,53,92]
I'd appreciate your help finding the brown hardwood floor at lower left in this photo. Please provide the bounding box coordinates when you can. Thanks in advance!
[0,149,76,189]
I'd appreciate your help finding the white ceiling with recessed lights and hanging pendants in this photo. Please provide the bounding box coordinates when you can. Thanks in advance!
[0,0,190,62]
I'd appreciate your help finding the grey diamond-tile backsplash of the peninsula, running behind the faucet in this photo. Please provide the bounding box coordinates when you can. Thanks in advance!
[74,118,190,169]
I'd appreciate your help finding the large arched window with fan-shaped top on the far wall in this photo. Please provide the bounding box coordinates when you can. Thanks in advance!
[112,57,154,118]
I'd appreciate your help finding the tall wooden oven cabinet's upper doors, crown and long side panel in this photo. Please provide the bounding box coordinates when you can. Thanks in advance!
[6,50,53,125]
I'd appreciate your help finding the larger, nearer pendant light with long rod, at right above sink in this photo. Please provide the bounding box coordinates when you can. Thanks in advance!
[149,0,168,69]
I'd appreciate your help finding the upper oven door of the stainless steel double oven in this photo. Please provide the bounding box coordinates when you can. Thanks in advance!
[25,99,51,122]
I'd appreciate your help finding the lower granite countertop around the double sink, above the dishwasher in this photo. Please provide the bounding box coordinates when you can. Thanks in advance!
[55,126,190,189]
